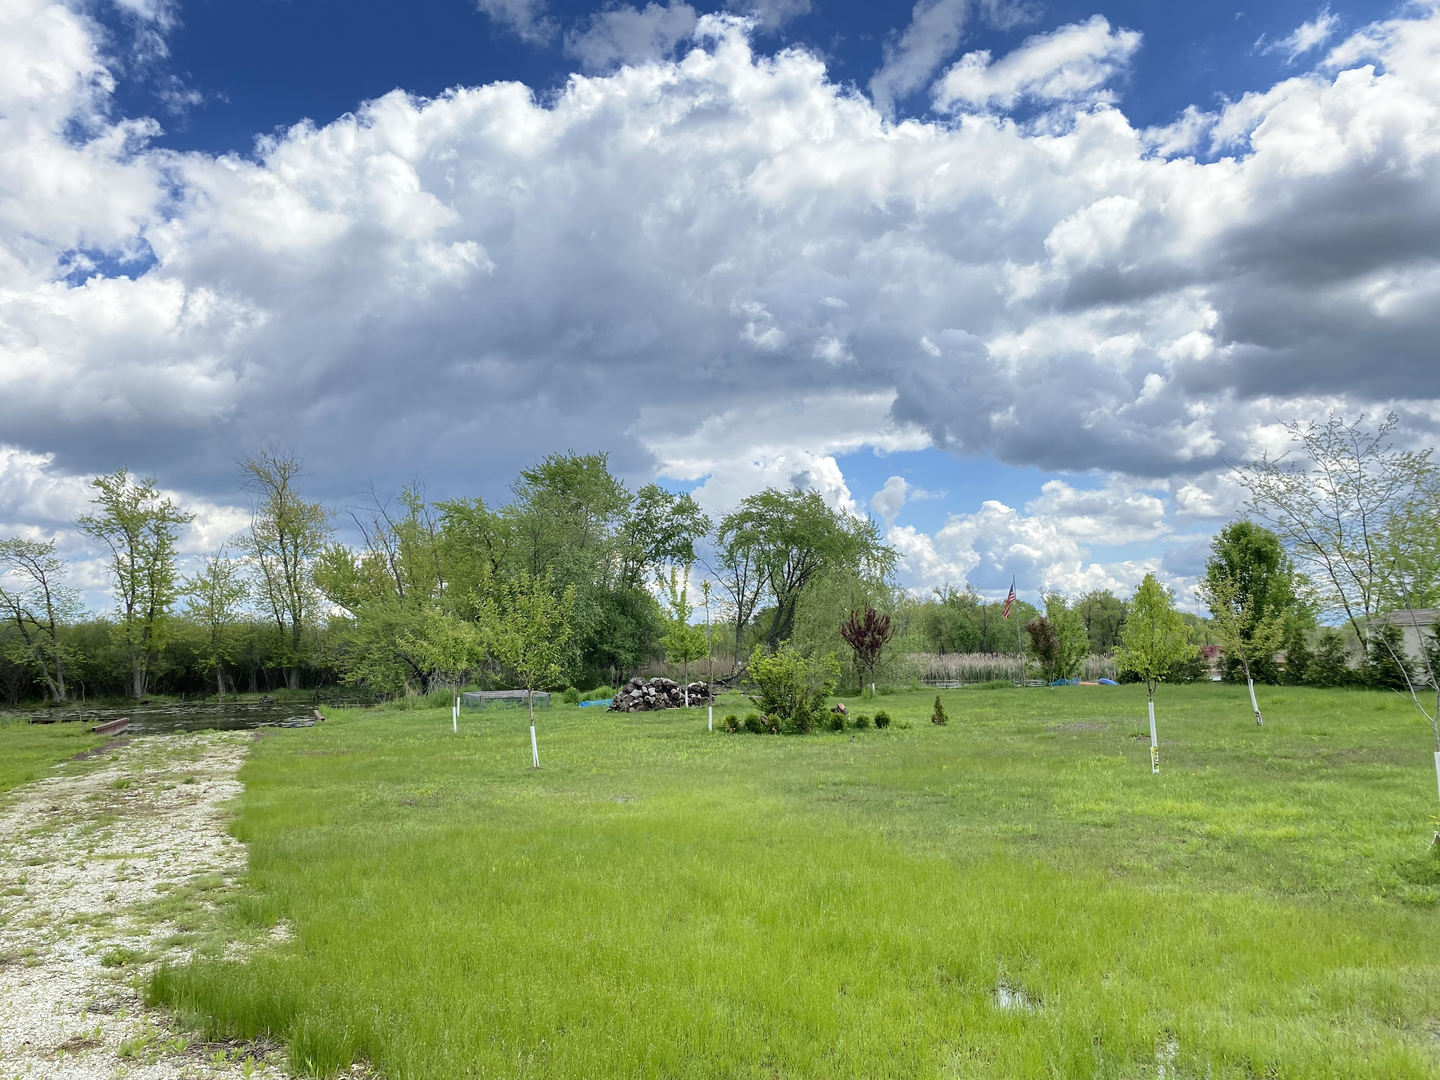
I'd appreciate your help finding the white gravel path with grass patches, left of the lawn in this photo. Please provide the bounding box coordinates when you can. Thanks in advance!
[0,732,287,1080]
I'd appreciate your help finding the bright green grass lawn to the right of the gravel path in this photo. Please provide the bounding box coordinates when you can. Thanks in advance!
[150,685,1440,1080]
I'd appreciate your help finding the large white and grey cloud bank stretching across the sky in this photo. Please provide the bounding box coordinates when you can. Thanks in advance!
[0,0,1440,601]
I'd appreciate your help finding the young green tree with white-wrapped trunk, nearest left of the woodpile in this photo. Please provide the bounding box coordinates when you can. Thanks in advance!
[481,572,575,769]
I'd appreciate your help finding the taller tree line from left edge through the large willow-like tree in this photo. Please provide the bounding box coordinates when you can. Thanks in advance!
[0,449,897,703]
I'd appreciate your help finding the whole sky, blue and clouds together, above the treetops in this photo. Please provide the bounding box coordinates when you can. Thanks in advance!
[0,0,1440,608]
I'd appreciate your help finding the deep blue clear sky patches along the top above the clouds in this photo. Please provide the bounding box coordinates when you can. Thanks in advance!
[112,0,1395,153]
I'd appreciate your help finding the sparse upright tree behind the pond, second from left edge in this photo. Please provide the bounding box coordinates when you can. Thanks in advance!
[76,468,194,698]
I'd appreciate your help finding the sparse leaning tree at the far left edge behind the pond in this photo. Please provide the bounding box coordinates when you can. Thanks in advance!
[0,537,81,703]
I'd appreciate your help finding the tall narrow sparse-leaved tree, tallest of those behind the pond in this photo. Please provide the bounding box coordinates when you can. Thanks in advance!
[238,448,330,690]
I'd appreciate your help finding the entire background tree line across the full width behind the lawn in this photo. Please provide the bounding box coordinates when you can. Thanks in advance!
[0,418,1440,720]
